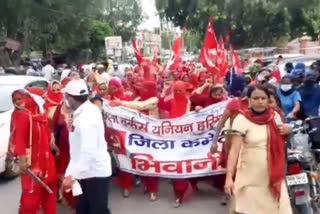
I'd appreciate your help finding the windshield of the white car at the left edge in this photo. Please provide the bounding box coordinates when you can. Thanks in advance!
[0,84,19,113]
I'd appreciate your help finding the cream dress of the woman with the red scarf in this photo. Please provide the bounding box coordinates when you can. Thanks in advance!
[232,114,292,214]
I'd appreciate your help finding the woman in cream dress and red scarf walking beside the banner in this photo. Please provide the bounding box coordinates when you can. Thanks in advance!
[225,85,292,214]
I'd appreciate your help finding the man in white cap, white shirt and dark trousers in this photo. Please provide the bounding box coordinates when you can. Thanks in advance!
[62,79,112,214]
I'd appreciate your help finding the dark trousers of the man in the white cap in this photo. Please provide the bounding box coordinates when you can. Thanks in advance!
[76,177,111,214]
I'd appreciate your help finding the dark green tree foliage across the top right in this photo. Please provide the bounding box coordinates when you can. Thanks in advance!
[156,0,320,47]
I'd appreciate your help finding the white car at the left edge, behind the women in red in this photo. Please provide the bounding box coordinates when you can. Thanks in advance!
[0,75,49,177]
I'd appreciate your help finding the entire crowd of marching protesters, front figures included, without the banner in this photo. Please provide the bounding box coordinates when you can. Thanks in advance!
[10,54,320,214]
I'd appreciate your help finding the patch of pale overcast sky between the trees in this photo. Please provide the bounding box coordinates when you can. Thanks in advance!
[139,0,160,31]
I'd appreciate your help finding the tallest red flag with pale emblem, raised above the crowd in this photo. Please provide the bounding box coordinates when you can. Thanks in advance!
[200,17,218,72]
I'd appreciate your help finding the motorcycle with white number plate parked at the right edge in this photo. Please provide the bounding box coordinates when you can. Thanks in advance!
[286,117,320,214]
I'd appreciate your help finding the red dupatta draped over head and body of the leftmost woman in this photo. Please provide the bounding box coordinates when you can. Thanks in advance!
[10,90,56,183]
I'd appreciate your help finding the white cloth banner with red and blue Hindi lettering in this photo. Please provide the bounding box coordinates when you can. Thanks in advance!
[104,102,227,178]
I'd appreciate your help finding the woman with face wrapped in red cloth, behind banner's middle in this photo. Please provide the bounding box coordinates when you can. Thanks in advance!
[159,81,191,208]
